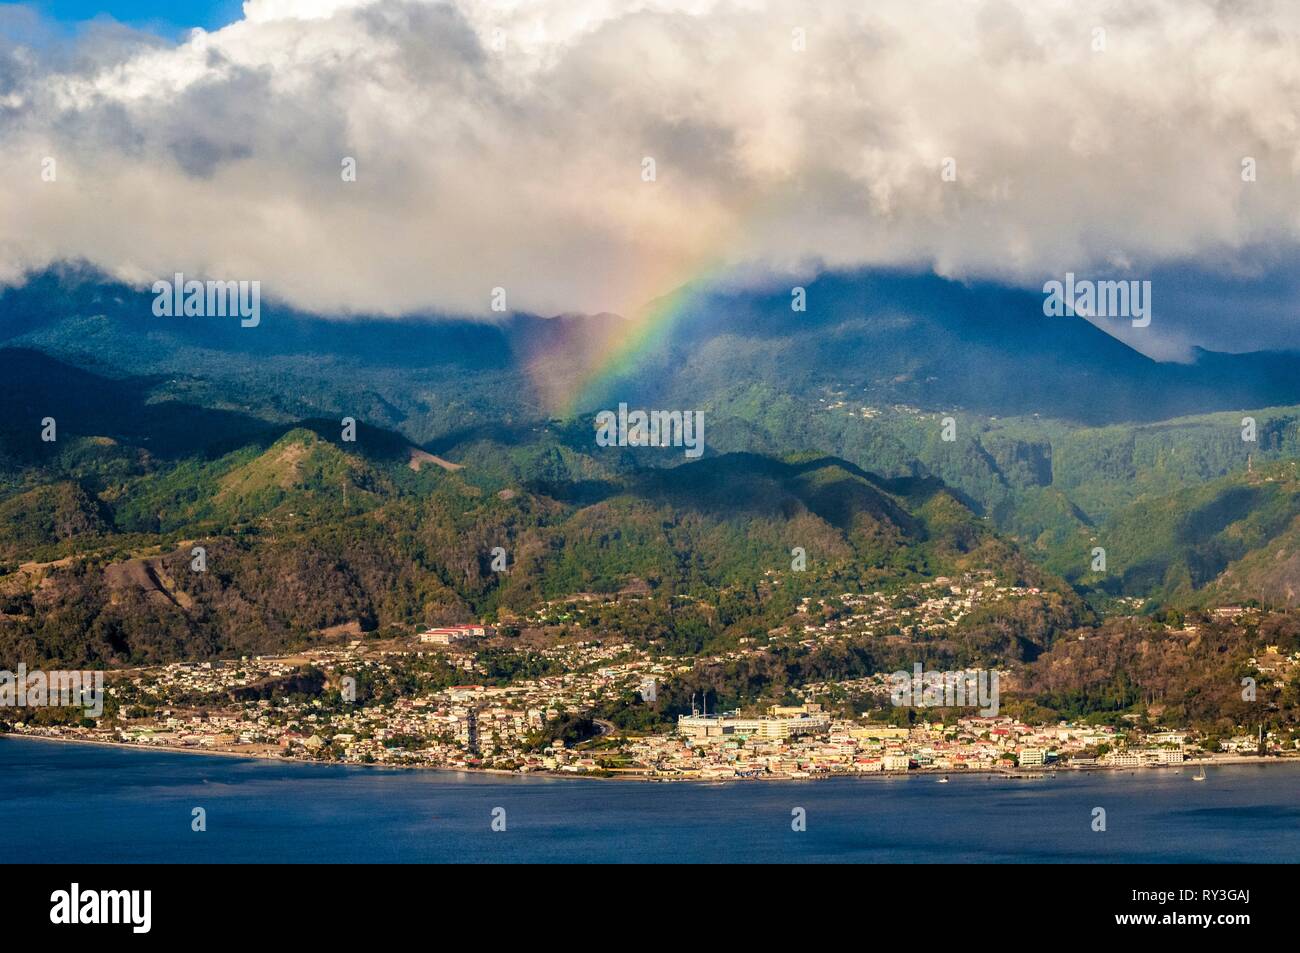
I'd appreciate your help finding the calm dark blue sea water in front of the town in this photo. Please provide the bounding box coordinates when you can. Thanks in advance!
[0,738,1300,863]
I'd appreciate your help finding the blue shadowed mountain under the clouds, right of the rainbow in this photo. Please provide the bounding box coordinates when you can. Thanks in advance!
[582,273,1300,425]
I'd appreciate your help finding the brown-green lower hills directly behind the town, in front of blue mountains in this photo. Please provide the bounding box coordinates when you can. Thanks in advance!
[0,351,1083,664]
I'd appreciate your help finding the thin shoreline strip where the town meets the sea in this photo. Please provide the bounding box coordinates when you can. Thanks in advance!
[0,732,1300,784]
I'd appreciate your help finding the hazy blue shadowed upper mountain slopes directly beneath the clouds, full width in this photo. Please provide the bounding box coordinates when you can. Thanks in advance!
[0,269,1300,431]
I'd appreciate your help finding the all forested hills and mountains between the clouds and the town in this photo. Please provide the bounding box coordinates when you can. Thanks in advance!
[0,262,1300,731]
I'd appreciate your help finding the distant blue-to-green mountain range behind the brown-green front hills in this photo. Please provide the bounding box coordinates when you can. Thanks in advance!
[10,268,1300,527]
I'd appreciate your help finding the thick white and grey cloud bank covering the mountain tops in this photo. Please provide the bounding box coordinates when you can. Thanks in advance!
[0,0,1300,330]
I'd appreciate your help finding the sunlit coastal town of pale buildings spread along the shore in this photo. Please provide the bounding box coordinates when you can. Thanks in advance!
[8,575,1300,780]
